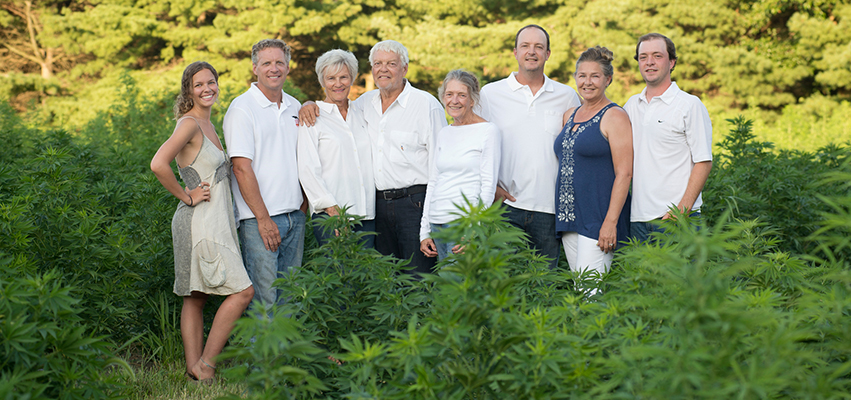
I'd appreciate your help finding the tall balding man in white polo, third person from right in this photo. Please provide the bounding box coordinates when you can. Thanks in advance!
[481,25,580,269]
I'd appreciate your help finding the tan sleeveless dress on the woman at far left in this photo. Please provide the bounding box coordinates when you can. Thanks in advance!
[171,117,251,296]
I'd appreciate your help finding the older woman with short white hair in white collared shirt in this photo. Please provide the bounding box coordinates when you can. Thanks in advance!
[298,49,375,248]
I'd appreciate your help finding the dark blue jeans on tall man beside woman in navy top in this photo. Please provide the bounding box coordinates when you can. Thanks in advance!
[505,204,561,270]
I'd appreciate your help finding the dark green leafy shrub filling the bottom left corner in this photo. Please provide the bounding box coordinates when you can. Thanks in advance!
[0,253,132,399]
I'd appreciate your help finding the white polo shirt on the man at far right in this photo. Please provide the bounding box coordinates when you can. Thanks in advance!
[624,82,712,222]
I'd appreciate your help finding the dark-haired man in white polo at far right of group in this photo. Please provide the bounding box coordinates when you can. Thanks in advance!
[624,33,712,241]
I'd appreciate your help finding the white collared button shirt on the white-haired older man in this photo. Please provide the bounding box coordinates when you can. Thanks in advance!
[350,80,446,190]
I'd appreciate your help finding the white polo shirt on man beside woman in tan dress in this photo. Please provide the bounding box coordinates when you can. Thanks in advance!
[223,82,302,221]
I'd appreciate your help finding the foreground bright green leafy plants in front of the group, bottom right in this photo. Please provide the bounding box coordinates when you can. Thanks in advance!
[221,187,851,399]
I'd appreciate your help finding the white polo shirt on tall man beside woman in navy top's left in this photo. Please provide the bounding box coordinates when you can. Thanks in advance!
[482,72,580,214]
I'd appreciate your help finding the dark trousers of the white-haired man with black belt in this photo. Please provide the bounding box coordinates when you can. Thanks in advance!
[375,193,435,274]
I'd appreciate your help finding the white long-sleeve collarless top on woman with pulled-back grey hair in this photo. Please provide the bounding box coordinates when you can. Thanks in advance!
[420,122,502,240]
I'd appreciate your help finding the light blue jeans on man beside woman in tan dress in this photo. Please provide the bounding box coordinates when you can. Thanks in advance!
[239,210,305,307]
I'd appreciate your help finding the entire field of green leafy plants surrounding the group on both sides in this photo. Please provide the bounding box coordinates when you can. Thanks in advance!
[0,93,851,399]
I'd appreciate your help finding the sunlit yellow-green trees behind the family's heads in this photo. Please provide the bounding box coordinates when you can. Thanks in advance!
[5,0,851,150]
